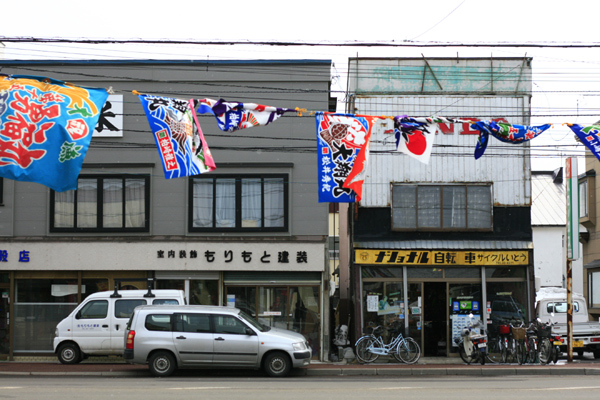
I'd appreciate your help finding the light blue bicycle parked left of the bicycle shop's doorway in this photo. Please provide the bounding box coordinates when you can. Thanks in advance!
[355,326,421,364]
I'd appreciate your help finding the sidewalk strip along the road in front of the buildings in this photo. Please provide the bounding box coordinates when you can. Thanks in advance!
[0,357,600,379]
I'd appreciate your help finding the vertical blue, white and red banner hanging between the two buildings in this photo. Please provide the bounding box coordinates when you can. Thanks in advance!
[316,112,380,203]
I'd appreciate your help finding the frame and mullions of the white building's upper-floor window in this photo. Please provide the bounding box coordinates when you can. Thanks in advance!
[390,182,494,232]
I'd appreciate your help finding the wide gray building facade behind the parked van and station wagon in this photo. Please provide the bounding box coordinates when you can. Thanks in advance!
[0,60,331,359]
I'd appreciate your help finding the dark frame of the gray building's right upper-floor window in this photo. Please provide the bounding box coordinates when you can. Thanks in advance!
[188,174,289,232]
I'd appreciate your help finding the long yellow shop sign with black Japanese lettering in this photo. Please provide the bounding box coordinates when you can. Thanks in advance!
[355,249,529,266]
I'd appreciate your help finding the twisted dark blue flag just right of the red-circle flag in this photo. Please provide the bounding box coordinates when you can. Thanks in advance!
[471,121,552,160]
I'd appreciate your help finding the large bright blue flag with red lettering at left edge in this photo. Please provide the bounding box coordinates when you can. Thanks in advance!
[0,75,108,192]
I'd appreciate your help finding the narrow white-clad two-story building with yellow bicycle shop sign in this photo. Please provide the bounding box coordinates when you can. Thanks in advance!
[340,58,535,356]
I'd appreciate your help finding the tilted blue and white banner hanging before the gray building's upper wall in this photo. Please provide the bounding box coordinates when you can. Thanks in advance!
[134,92,217,179]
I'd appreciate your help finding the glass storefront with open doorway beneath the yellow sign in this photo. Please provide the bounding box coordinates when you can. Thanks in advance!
[361,266,529,357]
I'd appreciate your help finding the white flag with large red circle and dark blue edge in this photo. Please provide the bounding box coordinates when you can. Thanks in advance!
[394,115,466,164]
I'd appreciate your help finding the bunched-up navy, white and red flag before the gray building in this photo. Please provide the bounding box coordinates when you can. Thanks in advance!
[197,99,296,132]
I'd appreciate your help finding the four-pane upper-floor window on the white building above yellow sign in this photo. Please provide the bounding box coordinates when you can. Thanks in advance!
[392,184,492,231]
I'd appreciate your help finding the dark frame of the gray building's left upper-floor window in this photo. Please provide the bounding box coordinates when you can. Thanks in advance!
[50,174,150,233]
